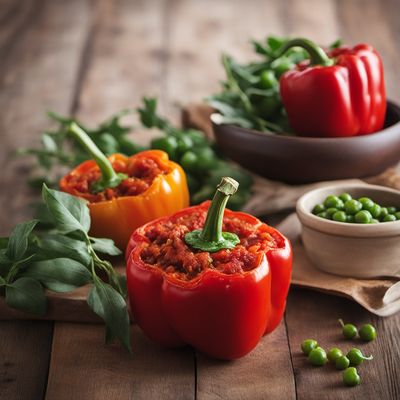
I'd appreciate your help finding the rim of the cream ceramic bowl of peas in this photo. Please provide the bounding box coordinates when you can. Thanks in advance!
[296,183,400,238]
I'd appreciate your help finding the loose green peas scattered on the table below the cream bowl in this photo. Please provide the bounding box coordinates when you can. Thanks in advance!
[301,320,376,386]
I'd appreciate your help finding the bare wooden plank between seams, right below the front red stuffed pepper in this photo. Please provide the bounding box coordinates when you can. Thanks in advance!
[197,322,296,400]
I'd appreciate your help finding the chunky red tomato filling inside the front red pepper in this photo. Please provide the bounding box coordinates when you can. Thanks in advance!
[141,210,282,281]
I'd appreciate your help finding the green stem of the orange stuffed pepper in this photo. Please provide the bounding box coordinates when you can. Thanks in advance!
[69,122,127,192]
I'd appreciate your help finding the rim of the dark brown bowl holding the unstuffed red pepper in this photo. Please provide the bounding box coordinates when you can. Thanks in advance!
[210,100,400,144]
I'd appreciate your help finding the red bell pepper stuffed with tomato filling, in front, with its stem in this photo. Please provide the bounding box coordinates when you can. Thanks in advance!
[126,178,292,359]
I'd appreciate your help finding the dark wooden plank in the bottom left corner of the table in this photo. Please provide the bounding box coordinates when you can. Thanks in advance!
[0,321,53,400]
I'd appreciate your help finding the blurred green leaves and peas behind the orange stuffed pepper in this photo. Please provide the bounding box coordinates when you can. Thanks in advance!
[18,97,253,210]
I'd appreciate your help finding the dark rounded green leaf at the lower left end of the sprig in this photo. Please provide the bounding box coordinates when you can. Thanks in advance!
[6,278,47,315]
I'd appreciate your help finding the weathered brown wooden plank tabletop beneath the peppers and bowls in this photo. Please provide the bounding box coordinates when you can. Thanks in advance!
[0,0,400,400]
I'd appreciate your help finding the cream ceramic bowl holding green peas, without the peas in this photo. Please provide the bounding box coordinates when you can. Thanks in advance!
[296,184,400,278]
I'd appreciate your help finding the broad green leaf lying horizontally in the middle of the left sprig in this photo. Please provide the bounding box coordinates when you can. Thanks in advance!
[21,258,92,292]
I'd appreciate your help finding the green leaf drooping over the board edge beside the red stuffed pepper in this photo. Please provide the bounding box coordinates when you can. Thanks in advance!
[87,280,132,352]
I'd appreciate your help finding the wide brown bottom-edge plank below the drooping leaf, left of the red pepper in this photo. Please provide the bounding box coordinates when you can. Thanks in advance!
[46,323,195,400]
